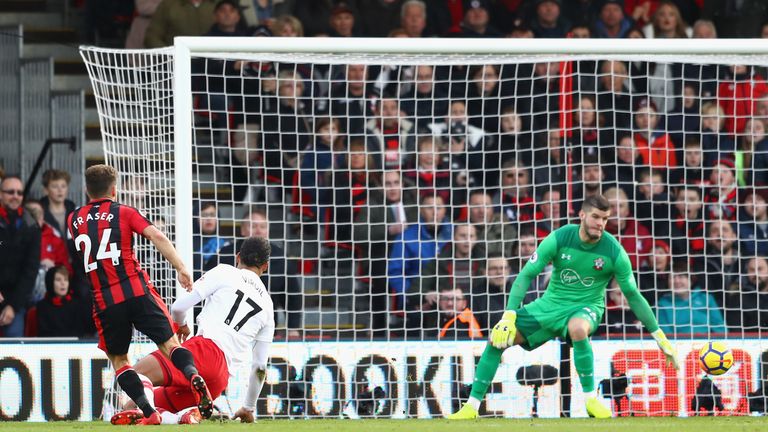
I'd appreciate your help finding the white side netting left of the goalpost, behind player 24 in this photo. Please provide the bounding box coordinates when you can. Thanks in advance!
[82,49,176,420]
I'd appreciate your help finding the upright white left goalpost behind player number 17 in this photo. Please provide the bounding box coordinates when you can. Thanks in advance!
[173,38,194,318]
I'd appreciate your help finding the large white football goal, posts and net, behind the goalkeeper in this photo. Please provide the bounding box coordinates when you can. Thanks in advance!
[81,38,768,417]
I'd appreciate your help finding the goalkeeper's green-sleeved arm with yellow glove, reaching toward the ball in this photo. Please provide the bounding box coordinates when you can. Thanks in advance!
[615,248,680,369]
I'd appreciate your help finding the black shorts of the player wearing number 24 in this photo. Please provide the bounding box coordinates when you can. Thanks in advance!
[93,290,174,355]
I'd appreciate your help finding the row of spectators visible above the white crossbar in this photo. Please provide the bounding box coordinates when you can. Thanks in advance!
[82,0,768,48]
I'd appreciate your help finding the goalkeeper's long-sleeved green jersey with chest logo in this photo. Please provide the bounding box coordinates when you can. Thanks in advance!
[507,225,659,332]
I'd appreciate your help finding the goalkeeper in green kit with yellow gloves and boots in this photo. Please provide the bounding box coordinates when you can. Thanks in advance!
[448,195,678,420]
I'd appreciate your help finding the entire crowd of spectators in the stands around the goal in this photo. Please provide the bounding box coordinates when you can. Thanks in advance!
[9,0,768,338]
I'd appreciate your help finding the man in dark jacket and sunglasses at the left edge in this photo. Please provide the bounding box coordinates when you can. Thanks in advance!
[0,176,40,337]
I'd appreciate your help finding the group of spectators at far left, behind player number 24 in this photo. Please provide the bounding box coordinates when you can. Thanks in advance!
[0,169,96,337]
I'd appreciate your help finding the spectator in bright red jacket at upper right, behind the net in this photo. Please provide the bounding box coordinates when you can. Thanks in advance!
[717,65,768,133]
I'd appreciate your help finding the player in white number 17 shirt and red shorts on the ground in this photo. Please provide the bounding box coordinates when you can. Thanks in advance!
[111,237,275,424]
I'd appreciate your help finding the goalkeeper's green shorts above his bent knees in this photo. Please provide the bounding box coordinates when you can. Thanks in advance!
[515,299,603,351]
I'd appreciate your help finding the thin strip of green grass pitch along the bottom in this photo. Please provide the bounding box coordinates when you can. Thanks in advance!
[0,417,768,432]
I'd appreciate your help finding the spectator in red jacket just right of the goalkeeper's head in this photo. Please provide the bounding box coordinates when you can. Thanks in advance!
[604,187,653,270]
